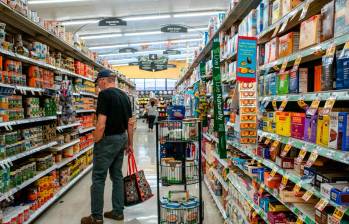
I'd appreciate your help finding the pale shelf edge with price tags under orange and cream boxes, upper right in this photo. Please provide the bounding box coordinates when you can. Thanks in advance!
[259,33,349,70]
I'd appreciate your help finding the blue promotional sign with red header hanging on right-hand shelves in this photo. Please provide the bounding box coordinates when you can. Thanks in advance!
[236,36,257,82]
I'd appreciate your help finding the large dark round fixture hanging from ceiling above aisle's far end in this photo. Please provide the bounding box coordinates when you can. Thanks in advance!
[138,54,168,72]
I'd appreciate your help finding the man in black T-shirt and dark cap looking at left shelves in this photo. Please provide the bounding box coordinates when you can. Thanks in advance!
[81,70,133,224]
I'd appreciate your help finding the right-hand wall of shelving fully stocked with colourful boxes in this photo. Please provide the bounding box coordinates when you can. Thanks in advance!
[176,0,349,224]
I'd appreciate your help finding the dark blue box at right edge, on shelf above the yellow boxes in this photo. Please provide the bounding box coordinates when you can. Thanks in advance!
[336,50,349,89]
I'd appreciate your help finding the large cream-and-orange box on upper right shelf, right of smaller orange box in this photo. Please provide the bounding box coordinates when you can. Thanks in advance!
[299,15,321,49]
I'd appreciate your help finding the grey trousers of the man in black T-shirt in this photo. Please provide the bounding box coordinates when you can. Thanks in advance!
[91,133,127,219]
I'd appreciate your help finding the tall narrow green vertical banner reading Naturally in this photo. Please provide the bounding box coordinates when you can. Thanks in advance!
[212,38,227,158]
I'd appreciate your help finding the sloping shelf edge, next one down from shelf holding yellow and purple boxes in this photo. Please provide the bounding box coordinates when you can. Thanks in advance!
[228,142,349,214]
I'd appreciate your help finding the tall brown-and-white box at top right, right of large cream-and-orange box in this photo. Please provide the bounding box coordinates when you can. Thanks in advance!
[320,1,334,42]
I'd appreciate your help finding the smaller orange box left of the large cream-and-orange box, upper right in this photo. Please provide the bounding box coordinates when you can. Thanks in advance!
[279,32,299,58]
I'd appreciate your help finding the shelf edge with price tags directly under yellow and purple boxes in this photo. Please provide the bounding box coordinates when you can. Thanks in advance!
[258,130,349,164]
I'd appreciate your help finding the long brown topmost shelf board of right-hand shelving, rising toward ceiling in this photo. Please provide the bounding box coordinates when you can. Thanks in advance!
[176,0,260,88]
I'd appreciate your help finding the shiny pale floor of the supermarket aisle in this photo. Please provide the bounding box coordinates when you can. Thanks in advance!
[35,121,223,224]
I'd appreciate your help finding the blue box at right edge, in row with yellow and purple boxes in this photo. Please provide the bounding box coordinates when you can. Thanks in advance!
[337,112,349,151]
